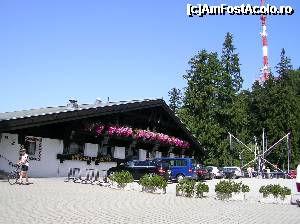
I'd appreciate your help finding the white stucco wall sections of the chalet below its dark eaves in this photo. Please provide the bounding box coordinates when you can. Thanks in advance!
[0,133,116,177]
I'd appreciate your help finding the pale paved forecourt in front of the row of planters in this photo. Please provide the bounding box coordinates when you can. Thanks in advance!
[0,179,300,224]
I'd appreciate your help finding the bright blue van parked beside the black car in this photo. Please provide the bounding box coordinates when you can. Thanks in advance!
[160,157,198,181]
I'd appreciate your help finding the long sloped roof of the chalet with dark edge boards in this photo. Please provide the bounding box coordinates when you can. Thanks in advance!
[0,99,201,150]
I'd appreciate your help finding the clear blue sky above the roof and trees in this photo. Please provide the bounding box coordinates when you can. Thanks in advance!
[0,0,300,112]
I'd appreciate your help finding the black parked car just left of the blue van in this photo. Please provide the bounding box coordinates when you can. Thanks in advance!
[107,160,171,180]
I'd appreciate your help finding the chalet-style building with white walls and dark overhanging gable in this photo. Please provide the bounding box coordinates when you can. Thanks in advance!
[0,99,202,177]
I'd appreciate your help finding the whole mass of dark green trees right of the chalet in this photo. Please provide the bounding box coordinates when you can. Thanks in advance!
[174,33,300,169]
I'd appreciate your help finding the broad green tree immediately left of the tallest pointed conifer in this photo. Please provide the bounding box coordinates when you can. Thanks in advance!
[179,50,236,165]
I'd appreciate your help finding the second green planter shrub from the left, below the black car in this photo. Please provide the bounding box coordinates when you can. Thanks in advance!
[139,174,168,193]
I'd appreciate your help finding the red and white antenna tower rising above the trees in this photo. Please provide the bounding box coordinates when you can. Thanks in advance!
[260,0,270,83]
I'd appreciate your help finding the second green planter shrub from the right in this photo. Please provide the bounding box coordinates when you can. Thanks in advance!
[215,180,250,200]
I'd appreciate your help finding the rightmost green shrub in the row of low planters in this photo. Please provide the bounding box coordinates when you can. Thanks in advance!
[259,184,291,200]
